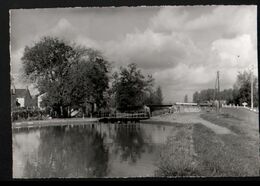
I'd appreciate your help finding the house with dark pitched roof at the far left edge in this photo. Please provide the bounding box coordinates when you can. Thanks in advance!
[11,88,37,109]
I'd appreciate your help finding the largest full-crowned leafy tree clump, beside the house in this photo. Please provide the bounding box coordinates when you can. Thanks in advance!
[22,37,109,117]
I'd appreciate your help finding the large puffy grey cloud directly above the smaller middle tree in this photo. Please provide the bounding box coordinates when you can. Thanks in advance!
[104,29,200,70]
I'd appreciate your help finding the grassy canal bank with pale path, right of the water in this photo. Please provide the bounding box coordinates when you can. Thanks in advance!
[147,112,259,177]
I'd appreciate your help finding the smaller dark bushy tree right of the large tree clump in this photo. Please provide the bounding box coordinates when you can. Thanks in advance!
[112,63,154,111]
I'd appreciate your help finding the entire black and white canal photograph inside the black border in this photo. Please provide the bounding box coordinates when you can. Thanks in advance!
[9,5,260,179]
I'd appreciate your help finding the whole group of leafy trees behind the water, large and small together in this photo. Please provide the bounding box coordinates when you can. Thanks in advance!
[22,37,162,117]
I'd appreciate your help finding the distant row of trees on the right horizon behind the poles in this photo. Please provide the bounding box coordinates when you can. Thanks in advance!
[193,71,258,107]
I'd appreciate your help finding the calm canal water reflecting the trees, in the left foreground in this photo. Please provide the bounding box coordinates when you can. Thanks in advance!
[13,123,173,178]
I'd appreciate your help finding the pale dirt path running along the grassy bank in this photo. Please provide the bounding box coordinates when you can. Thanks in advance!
[152,113,232,134]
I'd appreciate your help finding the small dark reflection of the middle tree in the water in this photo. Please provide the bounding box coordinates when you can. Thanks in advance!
[114,124,151,163]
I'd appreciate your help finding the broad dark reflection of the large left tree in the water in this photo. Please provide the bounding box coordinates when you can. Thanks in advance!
[21,126,108,178]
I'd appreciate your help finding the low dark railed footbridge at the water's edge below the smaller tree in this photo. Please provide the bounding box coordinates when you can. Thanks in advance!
[99,112,150,123]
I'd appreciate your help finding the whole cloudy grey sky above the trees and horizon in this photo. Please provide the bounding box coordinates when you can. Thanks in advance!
[10,6,257,103]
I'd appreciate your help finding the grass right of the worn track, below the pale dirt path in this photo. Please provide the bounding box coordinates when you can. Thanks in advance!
[193,124,259,177]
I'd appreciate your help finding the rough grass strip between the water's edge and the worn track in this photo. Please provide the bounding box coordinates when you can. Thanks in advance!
[155,125,200,177]
